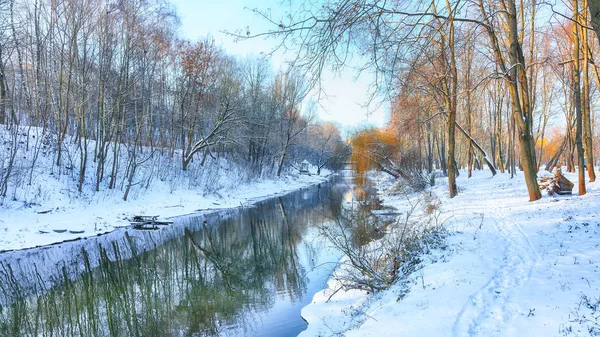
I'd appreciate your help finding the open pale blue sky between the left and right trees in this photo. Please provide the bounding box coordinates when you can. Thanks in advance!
[171,0,387,133]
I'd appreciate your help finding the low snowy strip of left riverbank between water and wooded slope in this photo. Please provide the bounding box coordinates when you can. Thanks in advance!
[0,169,328,251]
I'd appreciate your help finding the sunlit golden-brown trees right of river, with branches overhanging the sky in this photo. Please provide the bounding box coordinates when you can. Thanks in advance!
[262,0,600,201]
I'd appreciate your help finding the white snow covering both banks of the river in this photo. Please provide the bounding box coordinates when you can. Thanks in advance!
[0,122,600,337]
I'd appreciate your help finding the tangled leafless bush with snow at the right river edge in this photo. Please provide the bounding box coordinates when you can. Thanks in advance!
[321,194,446,293]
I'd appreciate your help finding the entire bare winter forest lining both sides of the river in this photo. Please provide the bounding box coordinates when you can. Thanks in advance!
[0,0,600,201]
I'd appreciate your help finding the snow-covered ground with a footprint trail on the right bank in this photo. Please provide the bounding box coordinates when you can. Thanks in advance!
[301,171,600,337]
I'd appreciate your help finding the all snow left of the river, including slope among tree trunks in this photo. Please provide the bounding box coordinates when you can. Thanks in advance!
[0,125,331,252]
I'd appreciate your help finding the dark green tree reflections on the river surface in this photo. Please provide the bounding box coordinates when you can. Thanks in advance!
[0,184,340,336]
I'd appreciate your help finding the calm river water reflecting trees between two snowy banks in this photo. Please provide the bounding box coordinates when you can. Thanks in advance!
[0,175,376,336]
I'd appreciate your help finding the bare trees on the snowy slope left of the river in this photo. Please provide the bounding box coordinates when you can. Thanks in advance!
[0,0,346,199]
